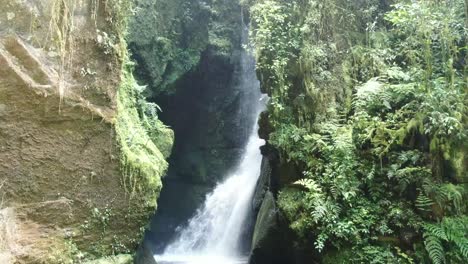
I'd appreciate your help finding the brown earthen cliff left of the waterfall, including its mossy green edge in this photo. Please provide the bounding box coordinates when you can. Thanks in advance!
[0,0,173,263]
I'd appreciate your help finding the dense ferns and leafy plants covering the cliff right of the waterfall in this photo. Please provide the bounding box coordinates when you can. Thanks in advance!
[247,0,468,263]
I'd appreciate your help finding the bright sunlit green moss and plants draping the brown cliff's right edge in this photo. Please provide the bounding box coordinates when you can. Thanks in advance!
[115,58,174,207]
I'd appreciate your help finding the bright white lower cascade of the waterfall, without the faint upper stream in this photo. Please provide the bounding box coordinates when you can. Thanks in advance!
[156,120,264,264]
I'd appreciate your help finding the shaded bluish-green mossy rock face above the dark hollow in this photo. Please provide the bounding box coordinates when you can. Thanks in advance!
[128,0,240,96]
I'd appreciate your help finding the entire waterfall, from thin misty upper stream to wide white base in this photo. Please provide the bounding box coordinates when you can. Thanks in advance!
[155,17,266,264]
